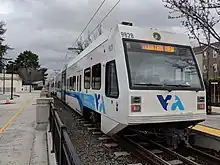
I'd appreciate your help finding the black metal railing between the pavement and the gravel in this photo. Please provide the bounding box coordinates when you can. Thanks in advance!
[49,103,83,165]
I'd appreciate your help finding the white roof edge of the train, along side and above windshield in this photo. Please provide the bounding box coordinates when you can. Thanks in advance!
[66,24,190,70]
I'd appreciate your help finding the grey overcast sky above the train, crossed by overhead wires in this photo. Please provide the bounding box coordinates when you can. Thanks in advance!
[0,0,186,76]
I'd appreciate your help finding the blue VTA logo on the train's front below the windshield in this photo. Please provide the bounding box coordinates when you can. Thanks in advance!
[157,95,184,111]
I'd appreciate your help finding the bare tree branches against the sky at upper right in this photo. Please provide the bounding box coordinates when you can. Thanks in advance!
[162,0,220,52]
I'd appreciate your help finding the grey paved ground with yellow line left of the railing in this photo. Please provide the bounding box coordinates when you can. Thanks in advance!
[0,92,48,165]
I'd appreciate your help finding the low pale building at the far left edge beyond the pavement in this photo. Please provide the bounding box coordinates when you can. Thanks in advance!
[0,73,22,94]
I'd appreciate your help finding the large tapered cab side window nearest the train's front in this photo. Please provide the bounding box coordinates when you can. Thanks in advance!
[105,60,119,98]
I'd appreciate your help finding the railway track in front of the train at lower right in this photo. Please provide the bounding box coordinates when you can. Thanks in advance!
[115,133,220,165]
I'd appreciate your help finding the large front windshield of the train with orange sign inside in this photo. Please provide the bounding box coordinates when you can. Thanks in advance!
[125,41,203,90]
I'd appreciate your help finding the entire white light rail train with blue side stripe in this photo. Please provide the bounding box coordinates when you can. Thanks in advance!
[53,24,206,135]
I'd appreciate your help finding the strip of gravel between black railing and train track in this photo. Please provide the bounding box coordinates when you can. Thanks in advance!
[55,100,142,165]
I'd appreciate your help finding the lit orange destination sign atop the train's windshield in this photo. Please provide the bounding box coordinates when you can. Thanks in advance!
[141,44,175,53]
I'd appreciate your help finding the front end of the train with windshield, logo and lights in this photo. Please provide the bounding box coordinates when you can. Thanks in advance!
[117,24,206,128]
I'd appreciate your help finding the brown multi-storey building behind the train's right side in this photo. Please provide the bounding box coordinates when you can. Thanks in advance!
[194,42,220,79]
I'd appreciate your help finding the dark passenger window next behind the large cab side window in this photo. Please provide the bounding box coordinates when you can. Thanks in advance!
[92,64,101,90]
